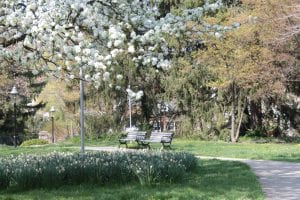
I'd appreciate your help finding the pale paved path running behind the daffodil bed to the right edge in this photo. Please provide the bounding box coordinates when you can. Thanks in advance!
[86,147,300,200]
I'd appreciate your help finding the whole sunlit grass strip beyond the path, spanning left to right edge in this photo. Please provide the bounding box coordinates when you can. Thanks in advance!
[0,136,300,162]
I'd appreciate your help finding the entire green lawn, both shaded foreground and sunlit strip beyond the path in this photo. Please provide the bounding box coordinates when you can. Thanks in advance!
[0,138,290,200]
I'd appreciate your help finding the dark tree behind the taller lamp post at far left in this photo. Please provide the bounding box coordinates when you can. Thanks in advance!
[0,58,45,144]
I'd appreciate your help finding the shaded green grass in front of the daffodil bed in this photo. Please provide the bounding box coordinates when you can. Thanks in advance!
[0,160,263,200]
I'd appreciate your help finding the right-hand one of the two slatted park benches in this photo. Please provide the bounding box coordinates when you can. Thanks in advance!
[140,132,174,149]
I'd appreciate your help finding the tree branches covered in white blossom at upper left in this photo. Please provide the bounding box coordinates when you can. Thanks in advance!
[0,0,237,89]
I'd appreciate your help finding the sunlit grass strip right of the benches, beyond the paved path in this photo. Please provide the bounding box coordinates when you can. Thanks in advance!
[173,139,300,162]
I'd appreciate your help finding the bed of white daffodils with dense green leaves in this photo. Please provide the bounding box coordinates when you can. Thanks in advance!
[0,151,197,188]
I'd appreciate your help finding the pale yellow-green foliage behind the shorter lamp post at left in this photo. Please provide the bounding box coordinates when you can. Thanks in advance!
[34,78,79,137]
